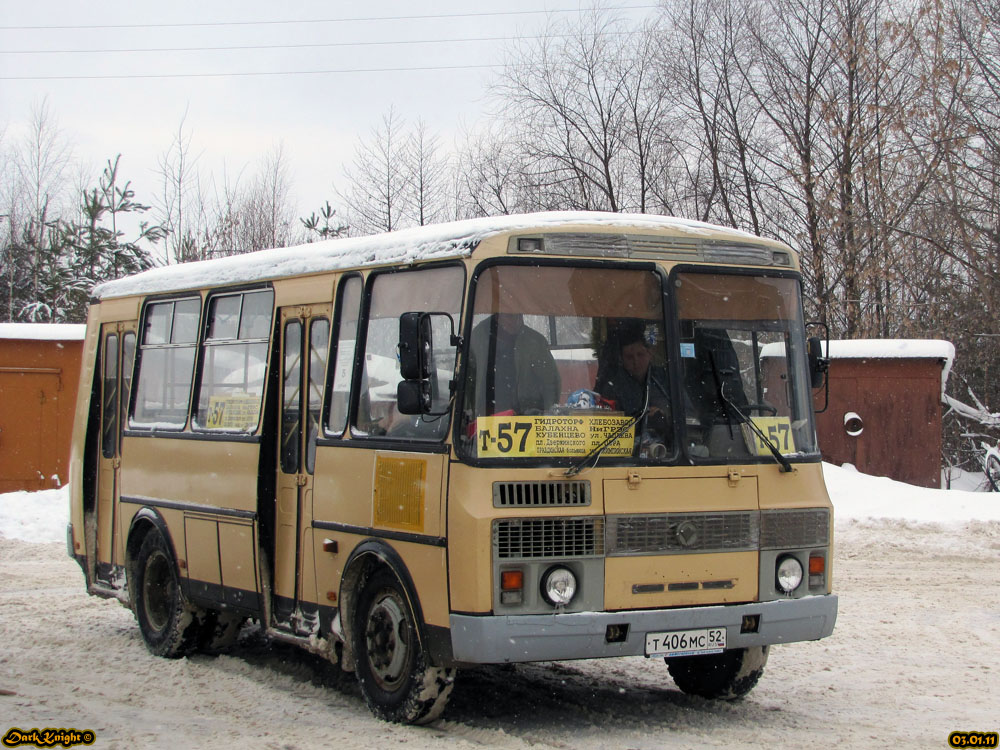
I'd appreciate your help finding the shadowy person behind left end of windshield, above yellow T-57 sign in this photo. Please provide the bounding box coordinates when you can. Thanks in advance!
[468,313,560,415]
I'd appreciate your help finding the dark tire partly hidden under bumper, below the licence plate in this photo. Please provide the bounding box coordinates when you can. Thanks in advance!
[665,646,769,701]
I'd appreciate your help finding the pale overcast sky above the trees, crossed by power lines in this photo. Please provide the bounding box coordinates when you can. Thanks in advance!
[0,0,655,226]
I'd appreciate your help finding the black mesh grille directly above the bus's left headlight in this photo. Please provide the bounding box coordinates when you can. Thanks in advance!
[493,517,604,560]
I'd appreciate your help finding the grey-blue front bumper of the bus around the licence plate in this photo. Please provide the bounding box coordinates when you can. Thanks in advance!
[451,594,837,664]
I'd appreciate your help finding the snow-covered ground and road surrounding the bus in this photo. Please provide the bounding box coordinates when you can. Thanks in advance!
[0,465,1000,750]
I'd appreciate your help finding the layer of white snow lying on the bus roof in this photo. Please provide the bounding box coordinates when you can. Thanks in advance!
[94,211,761,298]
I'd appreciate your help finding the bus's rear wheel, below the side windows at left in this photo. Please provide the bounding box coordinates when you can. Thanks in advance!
[134,529,203,659]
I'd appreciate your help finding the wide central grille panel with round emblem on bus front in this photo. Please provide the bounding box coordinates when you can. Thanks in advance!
[607,511,759,556]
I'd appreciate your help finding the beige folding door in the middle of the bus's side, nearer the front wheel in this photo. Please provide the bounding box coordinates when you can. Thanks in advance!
[272,305,330,632]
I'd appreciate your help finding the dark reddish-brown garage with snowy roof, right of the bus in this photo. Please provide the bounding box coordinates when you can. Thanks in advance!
[815,339,955,494]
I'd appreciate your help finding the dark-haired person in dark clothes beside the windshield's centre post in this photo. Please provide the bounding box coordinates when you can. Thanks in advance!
[594,323,670,442]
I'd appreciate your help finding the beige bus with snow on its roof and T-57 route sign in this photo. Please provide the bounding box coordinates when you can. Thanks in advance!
[68,213,837,723]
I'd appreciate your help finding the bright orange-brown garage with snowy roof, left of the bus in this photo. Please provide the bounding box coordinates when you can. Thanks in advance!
[0,323,85,492]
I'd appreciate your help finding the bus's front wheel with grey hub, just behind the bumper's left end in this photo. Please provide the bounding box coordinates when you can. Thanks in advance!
[353,568,455,724]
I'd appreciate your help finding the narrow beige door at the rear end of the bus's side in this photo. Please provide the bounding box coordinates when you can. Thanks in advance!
[93,323,135,584]
